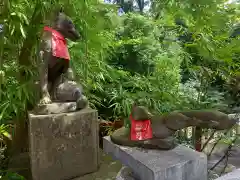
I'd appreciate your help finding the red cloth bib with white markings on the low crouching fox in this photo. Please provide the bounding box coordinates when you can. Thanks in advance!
[130,115,153,141]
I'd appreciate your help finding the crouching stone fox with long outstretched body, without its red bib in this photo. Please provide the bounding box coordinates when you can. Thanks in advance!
[110,105,237,150]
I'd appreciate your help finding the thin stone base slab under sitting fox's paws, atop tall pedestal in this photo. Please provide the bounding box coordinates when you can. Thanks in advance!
[33,102,76,115]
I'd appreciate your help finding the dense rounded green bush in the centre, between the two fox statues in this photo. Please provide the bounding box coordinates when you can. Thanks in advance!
[71,14,183,117]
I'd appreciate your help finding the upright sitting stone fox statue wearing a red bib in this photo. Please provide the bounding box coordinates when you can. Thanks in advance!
[39,10,87,109]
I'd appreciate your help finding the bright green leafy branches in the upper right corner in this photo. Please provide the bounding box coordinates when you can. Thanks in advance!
[152,0,240,109]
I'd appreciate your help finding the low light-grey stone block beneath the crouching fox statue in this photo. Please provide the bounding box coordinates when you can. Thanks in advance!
[103,136,207,180]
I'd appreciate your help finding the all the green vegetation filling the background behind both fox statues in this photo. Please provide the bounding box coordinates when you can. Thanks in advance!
[0,0,240,179]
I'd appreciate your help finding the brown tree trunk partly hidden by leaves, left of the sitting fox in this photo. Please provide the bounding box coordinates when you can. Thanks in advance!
[11,3,43,154]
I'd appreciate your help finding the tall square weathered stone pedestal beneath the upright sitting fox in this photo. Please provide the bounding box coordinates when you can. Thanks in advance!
[29,109,99,180]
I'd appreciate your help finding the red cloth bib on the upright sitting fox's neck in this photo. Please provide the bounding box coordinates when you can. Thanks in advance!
[44,26,70,60]
